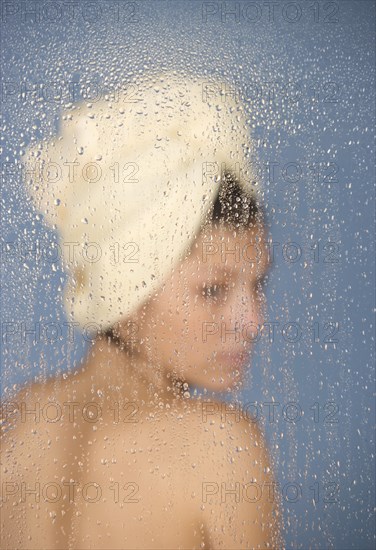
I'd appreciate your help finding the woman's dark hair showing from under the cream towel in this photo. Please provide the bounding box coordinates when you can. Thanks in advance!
[100,173,266,346]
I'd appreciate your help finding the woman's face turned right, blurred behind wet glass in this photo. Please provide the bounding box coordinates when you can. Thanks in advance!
[120,222,269,391]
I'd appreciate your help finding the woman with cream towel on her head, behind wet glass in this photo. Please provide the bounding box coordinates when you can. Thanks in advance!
[1,73,282,549]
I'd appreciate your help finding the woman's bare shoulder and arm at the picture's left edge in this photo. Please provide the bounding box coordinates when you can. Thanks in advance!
[0,375,92,549]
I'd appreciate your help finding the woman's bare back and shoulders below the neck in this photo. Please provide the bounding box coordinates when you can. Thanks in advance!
[1,364,277,550]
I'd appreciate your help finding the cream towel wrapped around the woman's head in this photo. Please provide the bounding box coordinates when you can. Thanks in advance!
[23,73,256,331]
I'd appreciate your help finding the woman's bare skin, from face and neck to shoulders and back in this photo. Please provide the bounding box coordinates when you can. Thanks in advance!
[1,222,282,550]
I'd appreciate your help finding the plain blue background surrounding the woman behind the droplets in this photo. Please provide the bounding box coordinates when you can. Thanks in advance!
[1,0,375,549]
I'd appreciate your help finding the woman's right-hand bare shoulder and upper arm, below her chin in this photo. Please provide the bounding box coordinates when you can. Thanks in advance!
[184,401,283,549]
